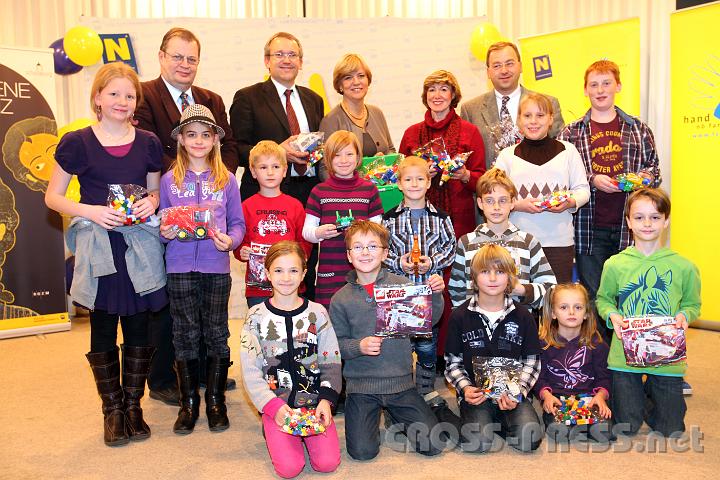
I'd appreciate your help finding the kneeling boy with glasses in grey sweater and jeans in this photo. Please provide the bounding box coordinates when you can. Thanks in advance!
[330,220,445,460]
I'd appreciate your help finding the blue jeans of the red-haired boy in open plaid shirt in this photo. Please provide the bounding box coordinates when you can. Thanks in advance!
[575,227,620,343]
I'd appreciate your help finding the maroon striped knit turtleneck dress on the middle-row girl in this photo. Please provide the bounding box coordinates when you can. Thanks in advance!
[305,172,383,308]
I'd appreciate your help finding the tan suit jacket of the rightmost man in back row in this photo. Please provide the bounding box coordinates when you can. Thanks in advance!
[460,85,565,169]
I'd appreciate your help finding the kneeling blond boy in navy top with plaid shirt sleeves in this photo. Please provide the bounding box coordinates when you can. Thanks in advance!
[445,243,542,452]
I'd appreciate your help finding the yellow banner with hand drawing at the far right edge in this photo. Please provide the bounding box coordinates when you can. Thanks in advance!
[670,3,720,322]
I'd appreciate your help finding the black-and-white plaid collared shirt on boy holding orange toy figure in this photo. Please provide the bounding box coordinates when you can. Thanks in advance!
[383,202,456,283]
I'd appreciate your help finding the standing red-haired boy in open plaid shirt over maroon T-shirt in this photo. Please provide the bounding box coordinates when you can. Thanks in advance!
[558,60,662,340]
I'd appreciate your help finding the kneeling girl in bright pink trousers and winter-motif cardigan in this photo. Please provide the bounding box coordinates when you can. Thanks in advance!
[240,240,341,478]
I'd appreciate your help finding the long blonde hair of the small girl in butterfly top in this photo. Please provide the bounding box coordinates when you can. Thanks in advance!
[539,283,603,350]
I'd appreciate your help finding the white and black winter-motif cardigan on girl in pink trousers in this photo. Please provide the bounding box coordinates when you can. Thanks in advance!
[240,299,342,416]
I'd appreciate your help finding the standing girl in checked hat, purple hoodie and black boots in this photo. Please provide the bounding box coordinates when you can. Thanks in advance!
[160,104,245,435]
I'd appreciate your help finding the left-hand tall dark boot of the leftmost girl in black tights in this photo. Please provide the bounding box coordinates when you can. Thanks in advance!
[85,347,130,447]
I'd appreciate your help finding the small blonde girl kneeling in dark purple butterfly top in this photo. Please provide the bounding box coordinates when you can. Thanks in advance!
[535,283,612,442]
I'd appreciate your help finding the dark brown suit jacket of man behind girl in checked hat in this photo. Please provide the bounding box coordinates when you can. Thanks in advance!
[135,77,238,173]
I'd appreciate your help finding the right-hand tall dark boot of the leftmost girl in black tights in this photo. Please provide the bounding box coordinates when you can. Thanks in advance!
[122,345,155,441]
